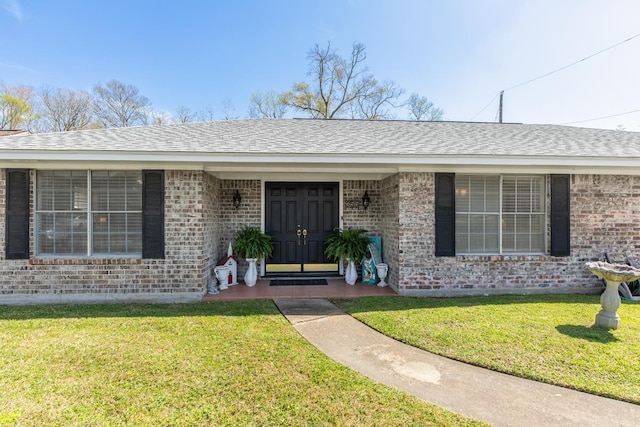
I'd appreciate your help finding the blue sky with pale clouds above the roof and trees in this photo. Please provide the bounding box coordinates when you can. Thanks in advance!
[0,0,640,131]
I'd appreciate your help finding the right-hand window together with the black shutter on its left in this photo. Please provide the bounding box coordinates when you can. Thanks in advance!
[435,173,546,256]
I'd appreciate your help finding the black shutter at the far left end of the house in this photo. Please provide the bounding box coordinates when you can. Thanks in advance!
[5,169,29,259]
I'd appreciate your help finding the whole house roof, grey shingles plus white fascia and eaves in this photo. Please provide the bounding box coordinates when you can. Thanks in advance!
[0,119,640,179]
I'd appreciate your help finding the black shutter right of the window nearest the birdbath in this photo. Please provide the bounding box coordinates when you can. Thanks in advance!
[551,175,571,256]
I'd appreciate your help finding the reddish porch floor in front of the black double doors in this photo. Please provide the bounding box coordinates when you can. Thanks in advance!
[202,277,396,301]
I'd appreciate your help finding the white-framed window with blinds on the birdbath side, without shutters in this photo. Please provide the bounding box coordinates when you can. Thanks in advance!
[455,175,546,254]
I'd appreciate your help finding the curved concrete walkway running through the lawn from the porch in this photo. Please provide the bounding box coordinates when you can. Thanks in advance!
[274,299,640,427]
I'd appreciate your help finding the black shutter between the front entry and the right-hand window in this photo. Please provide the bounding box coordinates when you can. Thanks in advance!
[435,173,456,256]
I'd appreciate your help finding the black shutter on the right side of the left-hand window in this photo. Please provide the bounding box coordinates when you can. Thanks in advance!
[142,170,164,258]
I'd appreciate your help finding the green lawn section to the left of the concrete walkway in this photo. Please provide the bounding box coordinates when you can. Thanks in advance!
[0,301,476,426]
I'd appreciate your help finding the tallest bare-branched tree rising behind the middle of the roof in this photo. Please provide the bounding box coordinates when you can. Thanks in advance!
[282,43,402,119]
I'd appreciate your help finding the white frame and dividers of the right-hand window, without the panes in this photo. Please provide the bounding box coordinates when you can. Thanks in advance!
[455,174,548,256]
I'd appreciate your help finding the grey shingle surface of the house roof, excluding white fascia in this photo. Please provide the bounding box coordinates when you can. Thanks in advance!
[0,119,640,158]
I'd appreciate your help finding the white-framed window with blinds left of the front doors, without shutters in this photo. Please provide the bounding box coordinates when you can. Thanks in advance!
[36,171,142,256]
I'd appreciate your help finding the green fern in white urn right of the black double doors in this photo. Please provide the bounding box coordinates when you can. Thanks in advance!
[324,228,369,285]
